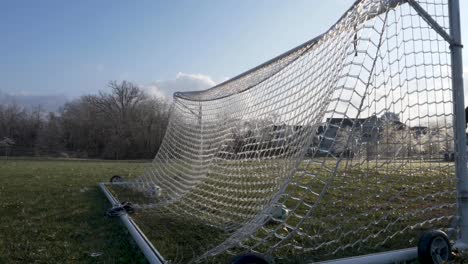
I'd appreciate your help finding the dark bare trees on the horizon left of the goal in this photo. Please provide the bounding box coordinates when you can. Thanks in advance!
[0,81,170,159]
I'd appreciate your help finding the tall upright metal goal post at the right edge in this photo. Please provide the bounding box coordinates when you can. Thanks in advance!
[449,0,468,250]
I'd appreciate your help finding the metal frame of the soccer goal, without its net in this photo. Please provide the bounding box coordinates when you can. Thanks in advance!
[99,0,468,264]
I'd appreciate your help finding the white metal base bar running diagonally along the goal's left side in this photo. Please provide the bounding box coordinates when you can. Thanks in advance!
[99,182,166,264]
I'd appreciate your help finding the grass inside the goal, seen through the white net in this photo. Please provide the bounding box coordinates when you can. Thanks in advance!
[106,160,456,263]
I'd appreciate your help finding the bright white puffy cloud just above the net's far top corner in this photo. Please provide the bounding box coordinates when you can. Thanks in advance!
[143,72,216,98]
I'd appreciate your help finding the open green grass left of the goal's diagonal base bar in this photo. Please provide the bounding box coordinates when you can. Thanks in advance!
[0,160,146,263]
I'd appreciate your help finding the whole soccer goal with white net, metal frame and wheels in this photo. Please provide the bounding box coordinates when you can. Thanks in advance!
[101,0,468,263]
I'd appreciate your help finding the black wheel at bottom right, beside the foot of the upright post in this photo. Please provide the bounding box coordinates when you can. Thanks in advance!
[418,230,452,264]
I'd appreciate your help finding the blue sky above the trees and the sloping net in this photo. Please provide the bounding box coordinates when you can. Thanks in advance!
[0,0,468,107]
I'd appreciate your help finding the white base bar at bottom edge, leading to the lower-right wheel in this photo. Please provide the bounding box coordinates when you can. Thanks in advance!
[319,247,418,264]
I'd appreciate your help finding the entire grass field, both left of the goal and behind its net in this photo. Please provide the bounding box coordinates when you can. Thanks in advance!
[0,160,464,263]
